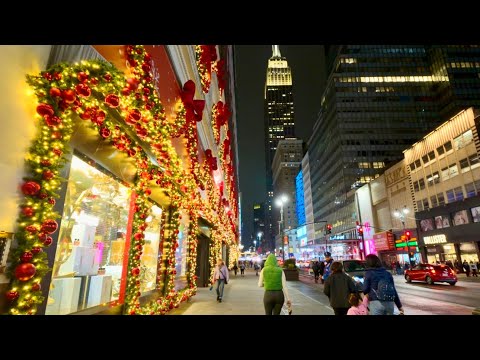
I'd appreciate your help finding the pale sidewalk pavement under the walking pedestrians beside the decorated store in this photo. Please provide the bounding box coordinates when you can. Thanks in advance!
[168,269,333,315]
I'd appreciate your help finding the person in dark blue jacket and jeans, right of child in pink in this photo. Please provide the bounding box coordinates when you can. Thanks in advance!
[363,254,403,315]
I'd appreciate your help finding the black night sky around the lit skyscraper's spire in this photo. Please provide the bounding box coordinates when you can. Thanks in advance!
[235,45,325,246]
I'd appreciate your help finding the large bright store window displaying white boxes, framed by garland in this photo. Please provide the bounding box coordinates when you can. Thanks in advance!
[46,155,131,314]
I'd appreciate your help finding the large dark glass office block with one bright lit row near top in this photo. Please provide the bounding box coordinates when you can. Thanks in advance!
[309,45,480,240]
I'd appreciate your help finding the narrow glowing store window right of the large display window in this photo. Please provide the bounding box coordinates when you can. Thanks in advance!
[140,205,162,292]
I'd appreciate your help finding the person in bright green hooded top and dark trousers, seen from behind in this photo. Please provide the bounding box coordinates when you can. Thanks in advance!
[258,254,292,315]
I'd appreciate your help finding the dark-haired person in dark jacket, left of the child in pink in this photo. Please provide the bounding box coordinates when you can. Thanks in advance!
[323,261,356,315]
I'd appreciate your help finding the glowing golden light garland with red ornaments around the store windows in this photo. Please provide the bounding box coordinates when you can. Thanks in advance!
[7,45,236,314]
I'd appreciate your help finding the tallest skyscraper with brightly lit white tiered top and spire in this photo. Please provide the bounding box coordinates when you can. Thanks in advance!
[264,45,295,250]
